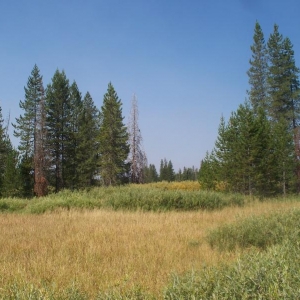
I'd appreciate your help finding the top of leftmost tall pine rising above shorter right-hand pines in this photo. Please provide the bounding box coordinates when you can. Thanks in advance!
[247,22,268,112]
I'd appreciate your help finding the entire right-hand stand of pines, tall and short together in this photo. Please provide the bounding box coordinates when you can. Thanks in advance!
[199,22,300,196]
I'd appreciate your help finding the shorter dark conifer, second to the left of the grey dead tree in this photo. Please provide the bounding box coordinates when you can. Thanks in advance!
[76,92,100,188]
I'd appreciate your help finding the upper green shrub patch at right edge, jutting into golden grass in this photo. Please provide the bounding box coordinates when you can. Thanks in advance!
[207,210,300,250]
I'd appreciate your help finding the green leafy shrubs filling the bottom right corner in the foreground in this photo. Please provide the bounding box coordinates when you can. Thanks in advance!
[164,240,300,300]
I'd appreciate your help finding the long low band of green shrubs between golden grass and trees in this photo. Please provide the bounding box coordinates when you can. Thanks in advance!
[0,183,245,214]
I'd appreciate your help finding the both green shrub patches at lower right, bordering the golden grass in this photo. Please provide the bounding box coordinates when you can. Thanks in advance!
[164,209,300,300]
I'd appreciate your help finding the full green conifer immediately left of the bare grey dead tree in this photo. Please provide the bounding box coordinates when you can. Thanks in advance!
[99,83,130,186]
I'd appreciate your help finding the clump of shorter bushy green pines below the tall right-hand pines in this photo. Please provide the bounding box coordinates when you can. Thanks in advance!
[212,103,275,194]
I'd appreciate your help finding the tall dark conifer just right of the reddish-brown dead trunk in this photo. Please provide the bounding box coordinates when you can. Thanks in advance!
[46,70,70,192]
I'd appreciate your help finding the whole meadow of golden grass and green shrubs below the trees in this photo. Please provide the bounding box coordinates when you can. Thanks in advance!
[0,183,300,299]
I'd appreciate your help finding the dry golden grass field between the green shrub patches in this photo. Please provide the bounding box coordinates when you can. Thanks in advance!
[0,202,300,295]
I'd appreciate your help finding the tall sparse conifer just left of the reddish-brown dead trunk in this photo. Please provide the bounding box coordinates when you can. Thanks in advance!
[13,65,44,196]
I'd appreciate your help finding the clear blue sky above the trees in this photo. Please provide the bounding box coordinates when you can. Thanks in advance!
[0,0,300,171]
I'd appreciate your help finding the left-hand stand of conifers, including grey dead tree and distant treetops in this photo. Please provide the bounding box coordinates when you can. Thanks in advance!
[0,65,197,197]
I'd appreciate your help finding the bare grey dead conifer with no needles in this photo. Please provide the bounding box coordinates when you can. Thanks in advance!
[128,95,147,183]
